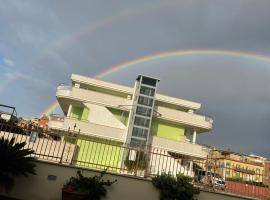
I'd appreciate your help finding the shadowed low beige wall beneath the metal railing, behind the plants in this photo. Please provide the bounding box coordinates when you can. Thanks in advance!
[9,162,253,200]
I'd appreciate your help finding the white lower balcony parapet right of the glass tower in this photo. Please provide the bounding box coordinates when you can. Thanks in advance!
[152,136,208,159]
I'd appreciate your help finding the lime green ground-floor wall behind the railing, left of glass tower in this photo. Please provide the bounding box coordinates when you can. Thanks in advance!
[76,138,121,170]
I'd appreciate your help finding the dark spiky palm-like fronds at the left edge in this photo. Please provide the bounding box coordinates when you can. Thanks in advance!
[0,137,36,190]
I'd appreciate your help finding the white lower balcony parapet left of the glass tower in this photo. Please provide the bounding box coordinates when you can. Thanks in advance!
[48,118,126,142]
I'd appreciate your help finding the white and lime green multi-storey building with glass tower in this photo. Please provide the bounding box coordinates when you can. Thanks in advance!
[49,74,213,174]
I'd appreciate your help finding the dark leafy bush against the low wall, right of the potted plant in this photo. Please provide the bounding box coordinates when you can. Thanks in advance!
[152,173,200,200]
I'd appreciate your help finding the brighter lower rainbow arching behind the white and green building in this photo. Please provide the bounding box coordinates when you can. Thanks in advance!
[41,49,270,115]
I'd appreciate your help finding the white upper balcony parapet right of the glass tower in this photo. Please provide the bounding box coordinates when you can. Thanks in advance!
[156,106,213,131]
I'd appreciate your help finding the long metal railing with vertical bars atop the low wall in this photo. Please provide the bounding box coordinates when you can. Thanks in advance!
[0,123,270,198]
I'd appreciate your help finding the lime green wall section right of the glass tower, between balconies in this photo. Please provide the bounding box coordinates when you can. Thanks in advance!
[151,119,185,141]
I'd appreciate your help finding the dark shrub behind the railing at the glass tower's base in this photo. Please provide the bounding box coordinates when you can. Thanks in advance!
[125,151,147,172]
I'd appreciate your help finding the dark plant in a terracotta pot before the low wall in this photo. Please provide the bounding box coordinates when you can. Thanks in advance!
[62,171,117,200]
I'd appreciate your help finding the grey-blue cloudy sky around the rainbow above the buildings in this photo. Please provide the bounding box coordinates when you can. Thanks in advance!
[0,0,270,158]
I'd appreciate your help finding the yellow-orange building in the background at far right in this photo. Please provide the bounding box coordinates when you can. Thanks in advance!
[209,150,266,182]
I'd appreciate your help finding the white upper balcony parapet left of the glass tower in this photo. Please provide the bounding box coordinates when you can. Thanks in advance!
[56,85,131,111]
